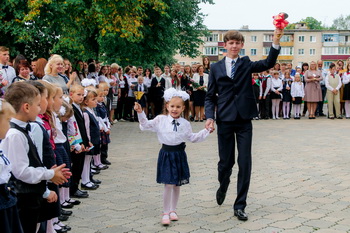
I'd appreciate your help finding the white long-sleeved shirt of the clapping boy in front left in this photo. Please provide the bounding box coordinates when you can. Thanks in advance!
[0,118,54,184]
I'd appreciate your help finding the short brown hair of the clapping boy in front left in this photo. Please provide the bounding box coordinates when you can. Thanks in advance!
[5,82,40,113]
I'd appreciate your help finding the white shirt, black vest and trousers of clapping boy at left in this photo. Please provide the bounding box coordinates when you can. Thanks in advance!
[2,118,54,233]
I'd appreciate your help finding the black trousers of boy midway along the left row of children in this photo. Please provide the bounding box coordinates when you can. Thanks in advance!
[69,151,85,195]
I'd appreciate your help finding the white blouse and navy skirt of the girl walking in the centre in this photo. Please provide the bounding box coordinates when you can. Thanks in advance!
[138,112,209,186]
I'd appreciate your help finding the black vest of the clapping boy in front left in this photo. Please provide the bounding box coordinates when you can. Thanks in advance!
[10,122,46,194]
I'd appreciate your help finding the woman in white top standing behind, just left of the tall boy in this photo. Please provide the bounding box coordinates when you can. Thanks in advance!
[192,65,209,122]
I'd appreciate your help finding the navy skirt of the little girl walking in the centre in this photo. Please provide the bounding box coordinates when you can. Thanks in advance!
[157,143,190,186]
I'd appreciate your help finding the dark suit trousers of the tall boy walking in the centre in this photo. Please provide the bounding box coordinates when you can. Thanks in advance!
[217,118,253,210]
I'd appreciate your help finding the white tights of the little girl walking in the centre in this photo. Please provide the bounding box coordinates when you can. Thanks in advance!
[163,184,180,213]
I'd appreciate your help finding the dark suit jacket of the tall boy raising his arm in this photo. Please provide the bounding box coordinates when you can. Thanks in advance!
[205,47,279,121]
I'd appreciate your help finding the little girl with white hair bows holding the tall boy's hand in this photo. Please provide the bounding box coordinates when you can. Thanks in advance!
[134,88,211,226]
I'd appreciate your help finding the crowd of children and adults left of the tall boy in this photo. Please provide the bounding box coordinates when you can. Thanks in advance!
[0,46,213,233]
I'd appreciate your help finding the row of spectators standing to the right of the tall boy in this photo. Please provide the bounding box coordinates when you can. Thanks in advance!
[252,58,350,120]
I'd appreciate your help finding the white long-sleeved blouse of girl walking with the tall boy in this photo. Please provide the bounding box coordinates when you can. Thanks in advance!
[137,112,209,146]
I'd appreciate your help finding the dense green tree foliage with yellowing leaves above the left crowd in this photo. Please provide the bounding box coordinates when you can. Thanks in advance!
[0,0,213,66]
